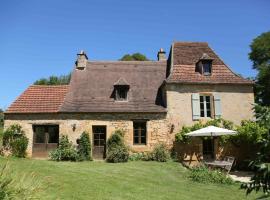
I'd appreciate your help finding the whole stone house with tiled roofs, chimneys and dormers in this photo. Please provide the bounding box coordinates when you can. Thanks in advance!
[5,42,254,159]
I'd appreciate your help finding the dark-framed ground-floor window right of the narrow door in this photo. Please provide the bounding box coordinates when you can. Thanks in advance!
[133,121,146,145]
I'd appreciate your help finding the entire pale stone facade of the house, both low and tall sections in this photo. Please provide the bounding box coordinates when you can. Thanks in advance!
[5,84,254,159]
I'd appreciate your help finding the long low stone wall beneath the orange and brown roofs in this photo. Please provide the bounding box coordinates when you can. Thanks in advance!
[5,113,171,156]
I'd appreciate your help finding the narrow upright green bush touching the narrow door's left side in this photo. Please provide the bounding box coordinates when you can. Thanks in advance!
[77,132,92,161]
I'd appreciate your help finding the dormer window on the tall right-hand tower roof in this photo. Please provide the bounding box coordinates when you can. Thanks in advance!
[195,53,213,76]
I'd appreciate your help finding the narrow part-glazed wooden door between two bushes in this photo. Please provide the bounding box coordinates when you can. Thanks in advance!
[92,126,106,159]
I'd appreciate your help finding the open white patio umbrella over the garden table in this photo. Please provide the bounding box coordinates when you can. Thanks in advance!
[187,126,237,137]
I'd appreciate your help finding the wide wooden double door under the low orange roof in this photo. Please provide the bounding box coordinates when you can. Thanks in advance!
[32,125,59,157]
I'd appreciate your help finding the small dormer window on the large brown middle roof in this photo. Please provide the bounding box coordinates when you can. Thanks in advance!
[114,78,129,101]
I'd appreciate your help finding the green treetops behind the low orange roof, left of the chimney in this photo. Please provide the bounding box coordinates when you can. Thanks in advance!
[34,73,71,85]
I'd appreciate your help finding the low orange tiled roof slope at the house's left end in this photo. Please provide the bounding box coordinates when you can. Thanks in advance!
[5,85,69,114]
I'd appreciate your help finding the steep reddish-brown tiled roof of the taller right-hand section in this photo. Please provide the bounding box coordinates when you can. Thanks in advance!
[167,42,253,84]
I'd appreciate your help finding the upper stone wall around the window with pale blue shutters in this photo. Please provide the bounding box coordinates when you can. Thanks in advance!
[166,84,254,131]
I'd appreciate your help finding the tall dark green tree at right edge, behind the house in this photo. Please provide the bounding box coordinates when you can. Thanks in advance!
[249,31,270,105]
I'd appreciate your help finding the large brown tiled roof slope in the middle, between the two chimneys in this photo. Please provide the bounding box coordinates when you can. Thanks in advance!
[60,61,167,112]
